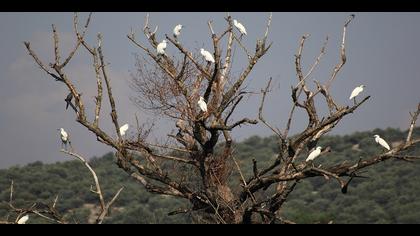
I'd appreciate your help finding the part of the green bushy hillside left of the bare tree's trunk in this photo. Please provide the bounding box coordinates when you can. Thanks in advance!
[0,154,191,224]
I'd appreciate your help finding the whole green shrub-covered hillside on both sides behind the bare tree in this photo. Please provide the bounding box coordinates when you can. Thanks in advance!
[0,128,420,223]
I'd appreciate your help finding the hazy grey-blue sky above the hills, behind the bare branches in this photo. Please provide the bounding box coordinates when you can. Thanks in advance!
[0,12,420,168]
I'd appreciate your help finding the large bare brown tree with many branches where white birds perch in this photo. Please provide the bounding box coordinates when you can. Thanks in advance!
[21,14,420,223]
